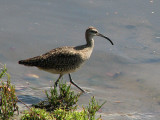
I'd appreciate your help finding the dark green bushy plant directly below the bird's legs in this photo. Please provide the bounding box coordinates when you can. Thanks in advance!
[33,81,80,111]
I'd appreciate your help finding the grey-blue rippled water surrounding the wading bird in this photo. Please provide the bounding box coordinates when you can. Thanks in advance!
[0,0,160,120]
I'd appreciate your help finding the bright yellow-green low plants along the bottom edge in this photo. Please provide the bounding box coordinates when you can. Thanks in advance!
[21,97,105,120]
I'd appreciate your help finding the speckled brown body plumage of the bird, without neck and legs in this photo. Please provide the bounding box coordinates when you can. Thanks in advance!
[19,46,92,74]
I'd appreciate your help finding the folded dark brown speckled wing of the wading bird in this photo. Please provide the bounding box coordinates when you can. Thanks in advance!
[19,47,82,69]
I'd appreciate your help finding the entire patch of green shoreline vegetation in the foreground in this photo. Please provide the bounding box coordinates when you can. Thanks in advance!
[0,65,105,120]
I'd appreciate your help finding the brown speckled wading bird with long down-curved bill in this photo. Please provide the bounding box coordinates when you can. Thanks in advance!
[19,27,113,92]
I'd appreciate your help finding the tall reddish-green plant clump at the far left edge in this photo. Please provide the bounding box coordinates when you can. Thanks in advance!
[0,65,18,120]
